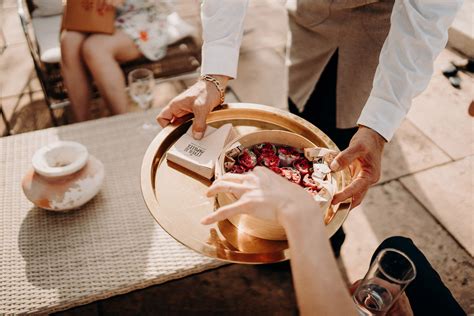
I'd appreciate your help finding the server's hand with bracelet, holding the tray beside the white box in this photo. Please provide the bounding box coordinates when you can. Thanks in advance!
[156,75,229,139]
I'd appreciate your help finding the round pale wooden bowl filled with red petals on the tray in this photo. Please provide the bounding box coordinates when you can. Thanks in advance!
[215,130,334,240]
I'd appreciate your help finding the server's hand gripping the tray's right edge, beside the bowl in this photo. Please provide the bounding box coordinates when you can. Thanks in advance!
[331,126,385,208]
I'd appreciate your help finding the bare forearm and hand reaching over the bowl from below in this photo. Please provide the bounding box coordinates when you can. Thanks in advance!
[201,167,357,315]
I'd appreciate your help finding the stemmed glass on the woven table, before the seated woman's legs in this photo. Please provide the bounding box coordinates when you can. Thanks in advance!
[128,68,159,131]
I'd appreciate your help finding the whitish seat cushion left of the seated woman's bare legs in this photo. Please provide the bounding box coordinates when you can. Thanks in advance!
[32,15,62,63]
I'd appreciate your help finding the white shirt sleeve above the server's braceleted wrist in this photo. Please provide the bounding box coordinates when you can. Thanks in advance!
[201,0,248,78]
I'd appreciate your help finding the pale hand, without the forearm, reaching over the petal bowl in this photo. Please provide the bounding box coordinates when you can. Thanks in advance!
[201,167,329,228]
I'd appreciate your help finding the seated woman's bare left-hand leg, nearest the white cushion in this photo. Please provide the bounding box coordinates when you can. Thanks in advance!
[61,30,92,121]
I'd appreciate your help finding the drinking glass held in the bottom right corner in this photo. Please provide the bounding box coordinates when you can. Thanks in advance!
[352,248,416,316]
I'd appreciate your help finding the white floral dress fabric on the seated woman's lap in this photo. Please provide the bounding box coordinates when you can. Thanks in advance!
[115,0,169,61]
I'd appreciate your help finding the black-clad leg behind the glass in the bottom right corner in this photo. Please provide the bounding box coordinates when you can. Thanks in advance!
[371,236,466,316]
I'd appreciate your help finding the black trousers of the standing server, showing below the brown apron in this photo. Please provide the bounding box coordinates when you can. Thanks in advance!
[288,51,357,257]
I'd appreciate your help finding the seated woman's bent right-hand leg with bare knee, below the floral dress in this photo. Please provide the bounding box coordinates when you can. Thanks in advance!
[82,31,141,114]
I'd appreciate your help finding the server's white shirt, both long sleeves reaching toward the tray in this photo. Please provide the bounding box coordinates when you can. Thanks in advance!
[201,0,462,141]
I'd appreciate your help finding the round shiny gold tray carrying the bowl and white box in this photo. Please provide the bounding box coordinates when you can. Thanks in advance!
[141,103,351,264]
